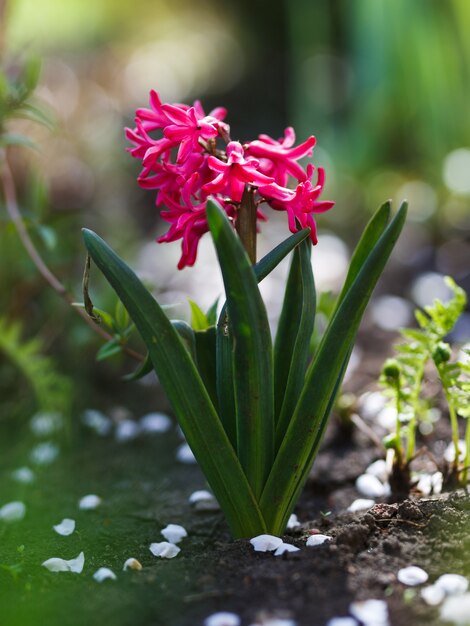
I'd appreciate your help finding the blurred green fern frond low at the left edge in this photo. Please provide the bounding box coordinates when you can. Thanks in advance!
[0,317,71,414]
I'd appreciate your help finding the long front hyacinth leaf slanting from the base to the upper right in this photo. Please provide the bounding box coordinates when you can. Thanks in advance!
[260,203,407,534]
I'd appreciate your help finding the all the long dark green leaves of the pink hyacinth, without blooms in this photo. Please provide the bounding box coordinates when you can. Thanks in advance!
[84,201,407,537]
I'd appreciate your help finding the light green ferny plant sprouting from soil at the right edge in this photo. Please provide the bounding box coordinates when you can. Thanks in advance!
[380,277,470,492]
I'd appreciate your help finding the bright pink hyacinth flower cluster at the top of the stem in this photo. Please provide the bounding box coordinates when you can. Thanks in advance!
[126,91,334,269]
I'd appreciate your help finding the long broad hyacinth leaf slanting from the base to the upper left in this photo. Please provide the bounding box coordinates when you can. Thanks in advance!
[83,229,266,537]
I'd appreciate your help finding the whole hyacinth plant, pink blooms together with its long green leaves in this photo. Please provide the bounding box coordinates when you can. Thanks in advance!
[84,92,406,537]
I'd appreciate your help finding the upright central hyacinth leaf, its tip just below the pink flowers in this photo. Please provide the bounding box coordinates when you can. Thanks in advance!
[206,200,274,497]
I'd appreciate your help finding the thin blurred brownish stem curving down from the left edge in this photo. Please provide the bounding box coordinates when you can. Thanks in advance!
[0,147,143,361]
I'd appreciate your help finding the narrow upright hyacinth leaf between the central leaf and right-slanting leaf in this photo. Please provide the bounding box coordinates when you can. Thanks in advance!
[274,240,316,449]
